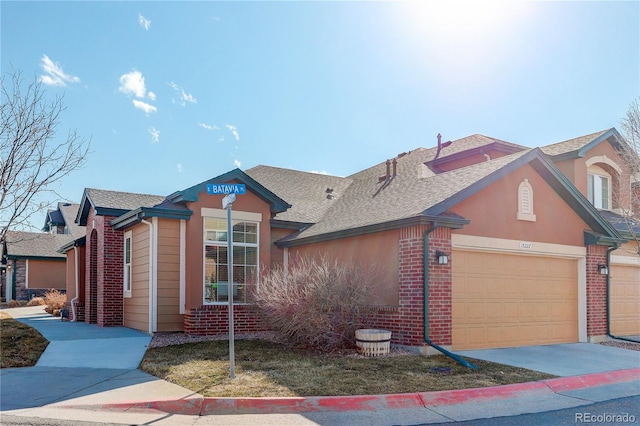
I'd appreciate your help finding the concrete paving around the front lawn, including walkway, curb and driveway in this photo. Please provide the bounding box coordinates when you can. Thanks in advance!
[0,307,640,426]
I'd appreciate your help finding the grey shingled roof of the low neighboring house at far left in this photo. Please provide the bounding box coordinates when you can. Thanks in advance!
[6,231,73,259]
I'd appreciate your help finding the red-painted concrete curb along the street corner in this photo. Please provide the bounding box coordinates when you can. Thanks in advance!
[60,368,640,416]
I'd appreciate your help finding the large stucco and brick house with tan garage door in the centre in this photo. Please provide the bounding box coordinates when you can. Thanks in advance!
[61,129,640,352]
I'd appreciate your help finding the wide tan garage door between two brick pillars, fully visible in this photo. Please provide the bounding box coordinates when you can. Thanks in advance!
[452,250,578,350]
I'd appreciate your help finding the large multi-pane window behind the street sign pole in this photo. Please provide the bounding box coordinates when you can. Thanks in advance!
[204,217,258,303]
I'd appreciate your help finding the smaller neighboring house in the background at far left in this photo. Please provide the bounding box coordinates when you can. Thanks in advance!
[2,203,85,300]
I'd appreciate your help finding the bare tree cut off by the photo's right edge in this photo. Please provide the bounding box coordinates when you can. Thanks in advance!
[620,98,640,255]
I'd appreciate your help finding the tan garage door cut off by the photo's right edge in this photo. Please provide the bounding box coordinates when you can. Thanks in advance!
[610,265,640,336]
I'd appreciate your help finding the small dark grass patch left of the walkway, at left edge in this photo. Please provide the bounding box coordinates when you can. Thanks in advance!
[0,311,49,368]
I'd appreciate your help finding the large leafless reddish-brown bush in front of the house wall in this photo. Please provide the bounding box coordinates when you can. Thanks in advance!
[254,257,375,352]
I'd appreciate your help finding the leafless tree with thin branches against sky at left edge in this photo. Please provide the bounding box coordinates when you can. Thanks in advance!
[0,71,90,242]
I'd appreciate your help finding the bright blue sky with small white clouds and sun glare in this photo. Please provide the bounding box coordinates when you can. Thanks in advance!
[0,1,640,225]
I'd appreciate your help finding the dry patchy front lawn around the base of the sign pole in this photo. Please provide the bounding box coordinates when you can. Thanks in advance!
[141,340,553,397]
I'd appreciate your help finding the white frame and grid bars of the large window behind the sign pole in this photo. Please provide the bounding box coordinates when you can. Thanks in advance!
[202,215,262,305]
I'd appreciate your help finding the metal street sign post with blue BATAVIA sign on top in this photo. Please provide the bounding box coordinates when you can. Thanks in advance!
[207,183,247,379]
